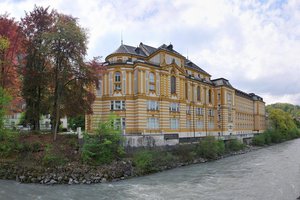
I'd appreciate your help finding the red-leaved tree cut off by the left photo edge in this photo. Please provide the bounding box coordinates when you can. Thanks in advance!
[0,14,24,109]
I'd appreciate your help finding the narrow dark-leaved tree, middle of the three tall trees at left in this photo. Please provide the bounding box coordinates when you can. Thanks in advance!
[21,6,56,131]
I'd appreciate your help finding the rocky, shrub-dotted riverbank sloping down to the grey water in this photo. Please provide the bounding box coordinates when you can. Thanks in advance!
[0,135,261,185]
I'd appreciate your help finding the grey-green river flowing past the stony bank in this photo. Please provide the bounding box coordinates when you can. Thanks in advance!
[0,139,300,200]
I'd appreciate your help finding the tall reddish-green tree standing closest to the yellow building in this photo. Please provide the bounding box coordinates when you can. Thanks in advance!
[44,14,97,140]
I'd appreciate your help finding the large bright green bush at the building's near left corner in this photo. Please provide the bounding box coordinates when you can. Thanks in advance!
[81,116,124,165]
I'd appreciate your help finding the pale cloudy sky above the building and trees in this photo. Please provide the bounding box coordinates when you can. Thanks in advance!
[0,0,300,105]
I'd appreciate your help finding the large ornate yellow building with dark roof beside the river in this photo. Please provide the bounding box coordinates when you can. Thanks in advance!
[86,43,265,146]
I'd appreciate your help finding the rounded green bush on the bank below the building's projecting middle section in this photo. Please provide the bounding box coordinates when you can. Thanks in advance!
[196,137,225,159]
